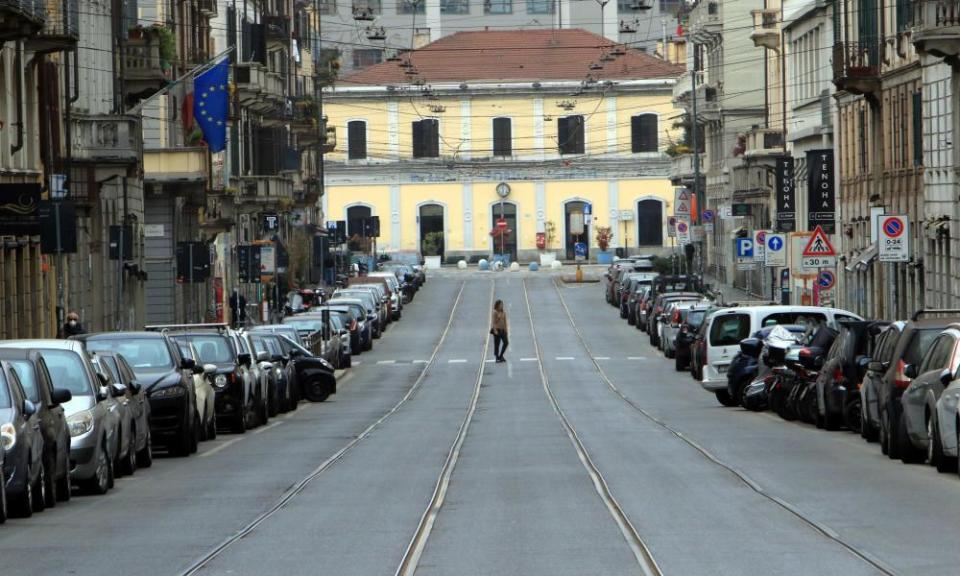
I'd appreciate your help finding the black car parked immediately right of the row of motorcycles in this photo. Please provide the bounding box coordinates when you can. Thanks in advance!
[816,320,889,433]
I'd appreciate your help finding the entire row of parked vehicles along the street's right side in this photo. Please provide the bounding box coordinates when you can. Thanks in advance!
[604,257,960,482]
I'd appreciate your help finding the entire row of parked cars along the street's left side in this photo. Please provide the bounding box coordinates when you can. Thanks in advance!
[0,266,426,522]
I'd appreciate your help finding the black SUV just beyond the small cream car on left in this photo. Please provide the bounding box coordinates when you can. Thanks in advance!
[162,325,263,434]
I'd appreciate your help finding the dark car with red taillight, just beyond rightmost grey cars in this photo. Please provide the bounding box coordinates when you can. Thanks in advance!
[874,317,960,460]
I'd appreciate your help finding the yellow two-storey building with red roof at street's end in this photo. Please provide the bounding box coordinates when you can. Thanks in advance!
[323,29,682,261]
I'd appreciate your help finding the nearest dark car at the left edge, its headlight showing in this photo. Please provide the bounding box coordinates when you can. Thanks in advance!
[0,360,47,518]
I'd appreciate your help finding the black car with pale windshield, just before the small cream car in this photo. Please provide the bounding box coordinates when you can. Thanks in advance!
[73,331,203,456]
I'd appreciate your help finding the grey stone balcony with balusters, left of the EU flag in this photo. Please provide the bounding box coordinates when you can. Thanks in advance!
[73,115,141,164]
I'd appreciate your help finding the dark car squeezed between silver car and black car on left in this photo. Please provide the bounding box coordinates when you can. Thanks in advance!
[97,352,156,474]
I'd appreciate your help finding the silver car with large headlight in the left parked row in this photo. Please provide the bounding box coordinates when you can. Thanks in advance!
[0,340,120,494]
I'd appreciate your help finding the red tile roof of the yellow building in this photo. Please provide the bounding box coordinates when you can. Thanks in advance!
[338,28,683,87]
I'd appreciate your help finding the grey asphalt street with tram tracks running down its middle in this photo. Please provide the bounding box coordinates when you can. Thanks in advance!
[0,272,960,576]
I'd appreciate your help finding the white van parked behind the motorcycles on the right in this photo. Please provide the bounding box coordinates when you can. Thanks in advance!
[701,306,862,401]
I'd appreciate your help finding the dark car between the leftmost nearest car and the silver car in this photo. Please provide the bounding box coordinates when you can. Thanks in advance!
[0,348,73,508]
